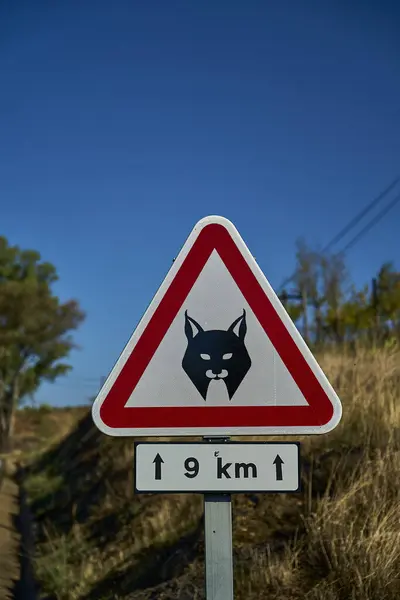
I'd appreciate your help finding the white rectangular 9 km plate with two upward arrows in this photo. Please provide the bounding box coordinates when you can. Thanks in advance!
[134,442,300,493]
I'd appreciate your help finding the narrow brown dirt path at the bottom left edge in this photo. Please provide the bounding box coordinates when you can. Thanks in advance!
[0,462,36,600]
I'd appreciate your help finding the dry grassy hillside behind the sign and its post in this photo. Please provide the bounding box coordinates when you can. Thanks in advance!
[19,348,400,600]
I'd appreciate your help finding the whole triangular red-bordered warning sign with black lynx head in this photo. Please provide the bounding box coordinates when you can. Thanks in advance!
[92,216,342,436]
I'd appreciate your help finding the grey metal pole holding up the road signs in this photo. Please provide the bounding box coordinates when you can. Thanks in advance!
[204,437,233,600]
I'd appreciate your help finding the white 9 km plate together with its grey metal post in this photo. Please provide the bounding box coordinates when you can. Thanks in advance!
[134,437,300,600]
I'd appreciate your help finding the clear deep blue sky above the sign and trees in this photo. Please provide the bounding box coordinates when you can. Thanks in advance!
[0,0,400,404]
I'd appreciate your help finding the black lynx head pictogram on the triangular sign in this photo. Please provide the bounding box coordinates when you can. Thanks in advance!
[182,310,251,400]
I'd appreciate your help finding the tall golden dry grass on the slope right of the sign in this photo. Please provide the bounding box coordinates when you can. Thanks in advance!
[237,348,400,600]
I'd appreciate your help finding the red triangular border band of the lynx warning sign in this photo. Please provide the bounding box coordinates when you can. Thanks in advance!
[100,223,334,430]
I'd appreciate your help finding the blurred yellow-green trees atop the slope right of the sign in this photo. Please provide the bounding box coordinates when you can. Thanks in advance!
[281,234,400,346]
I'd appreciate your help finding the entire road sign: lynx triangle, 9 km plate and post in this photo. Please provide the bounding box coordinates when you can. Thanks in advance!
[92,216,342,600]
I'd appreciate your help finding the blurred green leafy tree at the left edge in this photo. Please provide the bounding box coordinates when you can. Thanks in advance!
[0,237,84,450]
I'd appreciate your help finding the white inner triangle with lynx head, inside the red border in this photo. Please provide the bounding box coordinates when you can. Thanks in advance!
[126,250,308,407]
